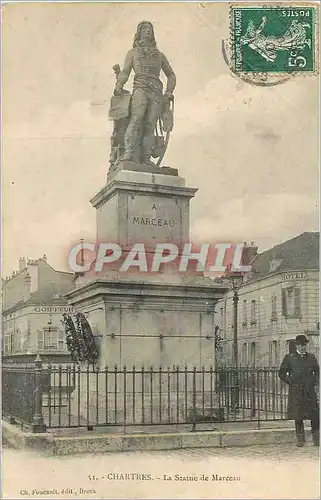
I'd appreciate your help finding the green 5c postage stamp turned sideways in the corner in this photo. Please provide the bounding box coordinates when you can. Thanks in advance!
[231,4,316,73]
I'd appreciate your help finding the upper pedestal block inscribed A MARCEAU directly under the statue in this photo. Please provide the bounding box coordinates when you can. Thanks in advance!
[90,162,197,248]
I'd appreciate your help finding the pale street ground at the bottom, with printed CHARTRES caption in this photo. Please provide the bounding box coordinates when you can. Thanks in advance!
[2,443,319,499]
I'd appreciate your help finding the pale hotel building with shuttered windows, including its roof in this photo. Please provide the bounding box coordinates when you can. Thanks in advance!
[216,233,320,367]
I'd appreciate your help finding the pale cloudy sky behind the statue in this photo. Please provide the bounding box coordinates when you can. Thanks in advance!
[2,3,319,276]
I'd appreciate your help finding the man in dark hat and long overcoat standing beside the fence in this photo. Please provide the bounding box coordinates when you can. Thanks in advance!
[279,335,320,447]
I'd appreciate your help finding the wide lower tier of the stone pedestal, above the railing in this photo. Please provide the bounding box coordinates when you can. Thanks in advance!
[69,271,225,367]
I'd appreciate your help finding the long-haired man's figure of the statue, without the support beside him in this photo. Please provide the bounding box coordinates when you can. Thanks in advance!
[114,21,176,164]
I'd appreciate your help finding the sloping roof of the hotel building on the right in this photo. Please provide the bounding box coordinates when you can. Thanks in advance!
[252,232,320,279]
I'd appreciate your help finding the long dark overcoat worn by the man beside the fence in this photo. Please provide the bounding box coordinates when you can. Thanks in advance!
[279,353,319,420]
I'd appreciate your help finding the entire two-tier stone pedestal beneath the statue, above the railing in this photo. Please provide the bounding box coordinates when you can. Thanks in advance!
[68,162,226,367]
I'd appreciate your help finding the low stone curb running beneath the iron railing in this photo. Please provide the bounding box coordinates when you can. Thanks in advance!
[2,422,295,455]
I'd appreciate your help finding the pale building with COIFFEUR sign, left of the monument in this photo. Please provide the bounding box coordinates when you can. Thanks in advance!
[2,256,74,360]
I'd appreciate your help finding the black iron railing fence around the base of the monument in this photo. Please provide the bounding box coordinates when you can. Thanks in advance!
[2,360,287,432]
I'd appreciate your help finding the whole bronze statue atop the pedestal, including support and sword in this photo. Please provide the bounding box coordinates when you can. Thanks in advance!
[109,21,176,168]
